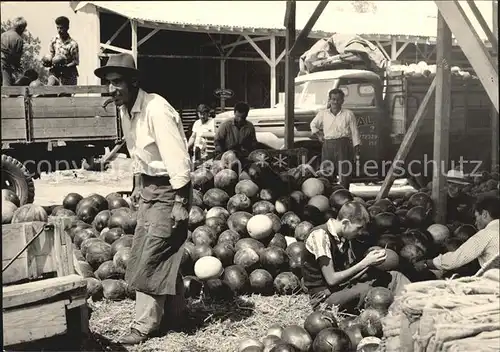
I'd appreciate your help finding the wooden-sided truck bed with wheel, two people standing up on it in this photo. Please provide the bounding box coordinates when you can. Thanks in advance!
[1,86,122,204]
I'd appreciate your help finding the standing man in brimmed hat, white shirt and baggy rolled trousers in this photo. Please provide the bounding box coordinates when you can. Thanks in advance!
[95,54,192,345]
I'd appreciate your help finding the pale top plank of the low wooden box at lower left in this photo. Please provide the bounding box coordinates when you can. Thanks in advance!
[2,274,87,309]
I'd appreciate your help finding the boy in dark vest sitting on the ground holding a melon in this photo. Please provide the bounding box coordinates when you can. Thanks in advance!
[302,201,410,311]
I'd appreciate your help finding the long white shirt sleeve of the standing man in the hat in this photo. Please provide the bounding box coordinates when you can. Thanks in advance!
[148,102,191,189]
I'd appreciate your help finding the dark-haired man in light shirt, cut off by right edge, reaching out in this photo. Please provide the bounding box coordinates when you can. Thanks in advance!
[415,196,500,271]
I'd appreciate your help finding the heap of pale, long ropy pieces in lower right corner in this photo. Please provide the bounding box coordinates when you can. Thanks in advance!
[382,269,500,352]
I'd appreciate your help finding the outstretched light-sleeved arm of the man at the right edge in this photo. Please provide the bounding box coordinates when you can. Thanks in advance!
[425,231,490,271]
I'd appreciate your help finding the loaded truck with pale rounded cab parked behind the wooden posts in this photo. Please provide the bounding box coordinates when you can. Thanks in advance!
[204,59,493,189]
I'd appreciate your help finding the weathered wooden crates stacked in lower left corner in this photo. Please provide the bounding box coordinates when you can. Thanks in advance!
[2,217,88,346]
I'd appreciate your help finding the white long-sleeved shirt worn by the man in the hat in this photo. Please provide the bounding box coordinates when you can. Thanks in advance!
[119,89,191,189]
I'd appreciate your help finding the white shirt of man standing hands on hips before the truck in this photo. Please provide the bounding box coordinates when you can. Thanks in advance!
[310,108,361,146]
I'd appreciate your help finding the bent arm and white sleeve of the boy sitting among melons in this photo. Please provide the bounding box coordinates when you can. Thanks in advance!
[306,229,368,287]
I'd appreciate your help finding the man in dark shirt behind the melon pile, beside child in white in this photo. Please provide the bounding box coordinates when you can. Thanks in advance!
[214,102,257,158]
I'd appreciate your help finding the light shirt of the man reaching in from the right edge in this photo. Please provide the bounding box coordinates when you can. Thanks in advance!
[432,219,500,270]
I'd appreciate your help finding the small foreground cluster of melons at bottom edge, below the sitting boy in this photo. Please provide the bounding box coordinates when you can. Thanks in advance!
[238,287,394,352]
